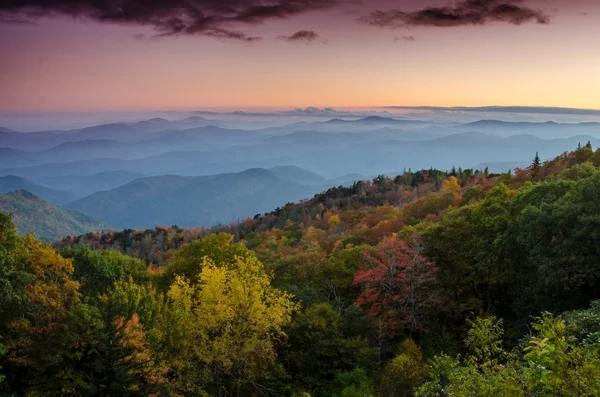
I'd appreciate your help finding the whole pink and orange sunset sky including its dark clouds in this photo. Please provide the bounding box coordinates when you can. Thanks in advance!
[0,0,600,114]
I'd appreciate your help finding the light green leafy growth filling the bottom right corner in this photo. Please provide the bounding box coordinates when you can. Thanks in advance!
[416,303,600,397]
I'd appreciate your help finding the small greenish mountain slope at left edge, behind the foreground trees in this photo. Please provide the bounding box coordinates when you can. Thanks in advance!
[0,190,106,241]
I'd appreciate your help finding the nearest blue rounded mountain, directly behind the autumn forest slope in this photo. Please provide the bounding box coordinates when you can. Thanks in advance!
[68,168,330,228]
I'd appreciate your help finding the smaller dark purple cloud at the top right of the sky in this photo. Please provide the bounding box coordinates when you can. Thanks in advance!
[359,0,550,28]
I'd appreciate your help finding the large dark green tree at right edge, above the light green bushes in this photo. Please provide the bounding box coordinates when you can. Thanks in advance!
[513,171,600,315]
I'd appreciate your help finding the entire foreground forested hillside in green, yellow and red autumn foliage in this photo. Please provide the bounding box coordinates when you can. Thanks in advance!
[0,144,600,397]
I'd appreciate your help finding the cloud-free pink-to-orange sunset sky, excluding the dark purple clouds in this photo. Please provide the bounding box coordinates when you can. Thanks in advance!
[0,0,600,112]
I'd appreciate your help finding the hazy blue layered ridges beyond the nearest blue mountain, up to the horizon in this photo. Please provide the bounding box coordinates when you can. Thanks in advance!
[0,116,600,193]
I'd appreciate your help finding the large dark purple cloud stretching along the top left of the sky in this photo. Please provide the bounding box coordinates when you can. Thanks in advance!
[0,0,338,42]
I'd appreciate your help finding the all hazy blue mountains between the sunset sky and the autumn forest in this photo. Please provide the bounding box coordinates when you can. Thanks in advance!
[0,116,600,232]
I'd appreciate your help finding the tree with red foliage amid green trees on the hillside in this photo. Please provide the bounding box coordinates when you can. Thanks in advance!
[354,237,442,332]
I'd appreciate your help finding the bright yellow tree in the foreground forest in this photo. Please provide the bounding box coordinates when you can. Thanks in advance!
[168,252,296,396]
